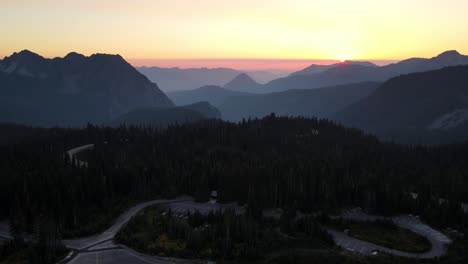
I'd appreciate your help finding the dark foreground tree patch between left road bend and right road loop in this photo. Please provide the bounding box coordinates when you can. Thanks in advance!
[117,207,334,260]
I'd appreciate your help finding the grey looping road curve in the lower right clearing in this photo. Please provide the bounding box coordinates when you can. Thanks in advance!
[328,209,452,259]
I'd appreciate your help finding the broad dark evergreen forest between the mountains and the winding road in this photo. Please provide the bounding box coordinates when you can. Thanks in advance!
[0,115,468,262]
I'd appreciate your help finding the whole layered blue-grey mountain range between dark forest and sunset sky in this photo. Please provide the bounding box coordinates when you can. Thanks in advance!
[0,50,468,143]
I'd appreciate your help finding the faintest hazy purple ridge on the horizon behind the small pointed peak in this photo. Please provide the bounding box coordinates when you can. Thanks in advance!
[137,67,285,92]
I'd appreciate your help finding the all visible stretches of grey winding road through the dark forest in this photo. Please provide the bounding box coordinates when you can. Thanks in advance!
[0,144,460,264]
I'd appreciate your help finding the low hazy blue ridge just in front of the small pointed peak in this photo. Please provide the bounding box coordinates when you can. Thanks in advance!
[167,85,248,106]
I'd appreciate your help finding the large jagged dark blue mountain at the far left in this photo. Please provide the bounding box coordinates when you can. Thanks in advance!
[0,50,173,126]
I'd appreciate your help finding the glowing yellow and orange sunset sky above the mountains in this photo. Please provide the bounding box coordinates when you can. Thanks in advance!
[0,0,468,69]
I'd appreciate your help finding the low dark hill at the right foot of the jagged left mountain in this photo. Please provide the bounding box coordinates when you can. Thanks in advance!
[110,103,220,127]
